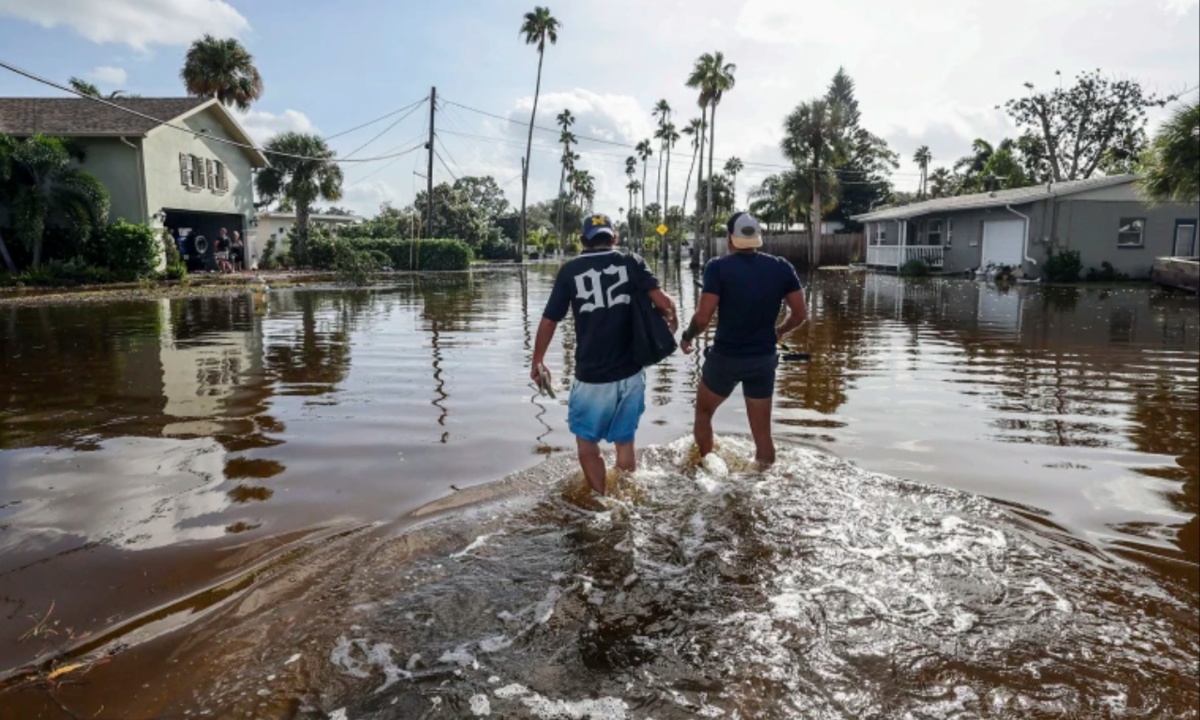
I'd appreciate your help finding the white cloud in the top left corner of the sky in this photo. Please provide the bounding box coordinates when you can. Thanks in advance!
[0,0,250,50]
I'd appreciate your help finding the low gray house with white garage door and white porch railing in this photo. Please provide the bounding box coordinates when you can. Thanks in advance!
[854,175,1200,278]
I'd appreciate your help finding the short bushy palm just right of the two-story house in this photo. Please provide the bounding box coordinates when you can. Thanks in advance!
[254,131,342,262]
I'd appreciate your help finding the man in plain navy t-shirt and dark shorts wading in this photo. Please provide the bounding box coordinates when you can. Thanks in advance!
[679,212,808,464]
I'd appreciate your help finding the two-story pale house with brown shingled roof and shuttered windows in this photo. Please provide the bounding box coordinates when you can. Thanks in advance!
[0,97,268,265]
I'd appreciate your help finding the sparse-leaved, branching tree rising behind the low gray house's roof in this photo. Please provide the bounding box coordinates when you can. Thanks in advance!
[1004,70,1175,182]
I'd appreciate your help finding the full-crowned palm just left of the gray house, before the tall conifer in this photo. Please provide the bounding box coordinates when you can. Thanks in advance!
[780,98,846,268]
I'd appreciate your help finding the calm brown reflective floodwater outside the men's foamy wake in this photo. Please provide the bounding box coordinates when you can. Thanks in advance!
[0,266,1200,716]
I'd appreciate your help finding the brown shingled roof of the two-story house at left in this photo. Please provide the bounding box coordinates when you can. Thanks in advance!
[0,97,211,137]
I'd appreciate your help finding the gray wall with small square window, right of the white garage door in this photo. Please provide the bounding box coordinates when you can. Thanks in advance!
[1054,199,1200,278]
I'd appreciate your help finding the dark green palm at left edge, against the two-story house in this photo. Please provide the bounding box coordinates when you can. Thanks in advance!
[0,134,109,271]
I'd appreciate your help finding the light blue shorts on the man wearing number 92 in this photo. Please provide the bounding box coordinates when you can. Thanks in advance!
[566,371,646,443]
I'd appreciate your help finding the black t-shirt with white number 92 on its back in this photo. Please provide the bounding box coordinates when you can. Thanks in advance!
[541,247,659,383]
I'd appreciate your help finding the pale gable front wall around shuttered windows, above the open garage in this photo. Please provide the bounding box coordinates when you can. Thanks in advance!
[145,110,254,228]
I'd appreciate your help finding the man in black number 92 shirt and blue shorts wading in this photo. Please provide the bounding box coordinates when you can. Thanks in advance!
[529,215,678,493]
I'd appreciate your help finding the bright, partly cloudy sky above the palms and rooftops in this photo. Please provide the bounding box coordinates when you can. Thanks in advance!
[0,0,1200,215]
